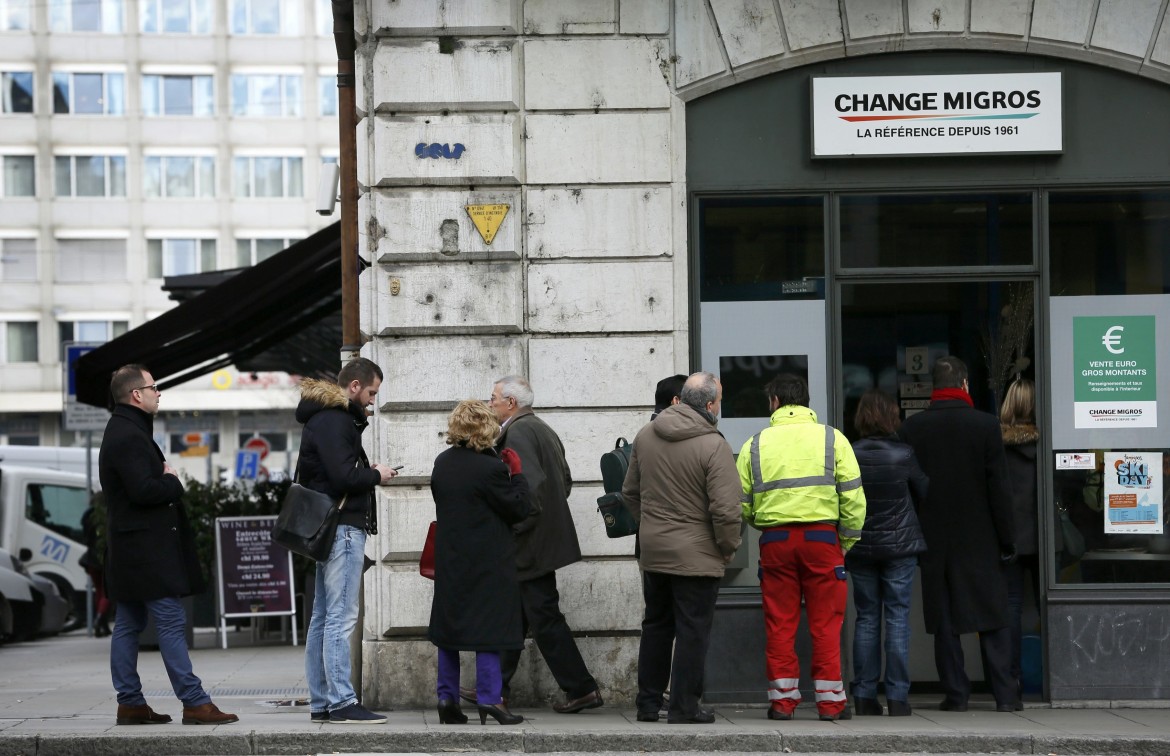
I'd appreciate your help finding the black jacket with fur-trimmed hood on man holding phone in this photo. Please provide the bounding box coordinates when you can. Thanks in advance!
[296,378,381,534]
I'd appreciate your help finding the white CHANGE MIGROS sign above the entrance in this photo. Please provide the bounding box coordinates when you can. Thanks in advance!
[812,73,1064,158]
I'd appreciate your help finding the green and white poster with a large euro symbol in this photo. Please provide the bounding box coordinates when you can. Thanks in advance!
[1073,315,1158,428]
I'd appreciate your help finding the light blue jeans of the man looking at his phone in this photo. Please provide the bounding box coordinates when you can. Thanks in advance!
[304,525,365,713]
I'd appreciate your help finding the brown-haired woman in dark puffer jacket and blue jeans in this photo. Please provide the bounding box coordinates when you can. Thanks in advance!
[845,389,927,716]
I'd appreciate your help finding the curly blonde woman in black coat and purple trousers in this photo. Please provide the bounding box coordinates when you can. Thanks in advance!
[427,399,529,724]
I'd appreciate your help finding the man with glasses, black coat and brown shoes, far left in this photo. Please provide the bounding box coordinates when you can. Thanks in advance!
[97,365,240,724]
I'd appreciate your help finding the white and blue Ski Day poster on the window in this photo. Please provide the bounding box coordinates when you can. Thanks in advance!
[1104,452,1162,535]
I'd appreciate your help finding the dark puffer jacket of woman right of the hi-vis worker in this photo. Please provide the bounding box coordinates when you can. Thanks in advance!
[845,437,928,564]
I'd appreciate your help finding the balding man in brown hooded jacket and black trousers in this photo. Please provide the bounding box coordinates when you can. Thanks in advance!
[621,372,741,724]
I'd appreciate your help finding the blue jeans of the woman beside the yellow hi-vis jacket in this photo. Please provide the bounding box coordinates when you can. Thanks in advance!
[849,556,918,701]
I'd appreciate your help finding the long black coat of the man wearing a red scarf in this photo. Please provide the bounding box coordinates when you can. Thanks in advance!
[899,399,1014,634]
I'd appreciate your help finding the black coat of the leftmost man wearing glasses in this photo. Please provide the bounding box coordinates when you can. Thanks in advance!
[97,404,207,602]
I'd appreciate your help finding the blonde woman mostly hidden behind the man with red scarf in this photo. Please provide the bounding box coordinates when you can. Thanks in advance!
[999,378,1040,706]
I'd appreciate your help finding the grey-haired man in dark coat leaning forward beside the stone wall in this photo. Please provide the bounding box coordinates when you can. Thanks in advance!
[489,376,601,714]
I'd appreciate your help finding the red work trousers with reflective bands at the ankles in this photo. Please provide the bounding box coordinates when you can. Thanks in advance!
[759,523,848,714]
